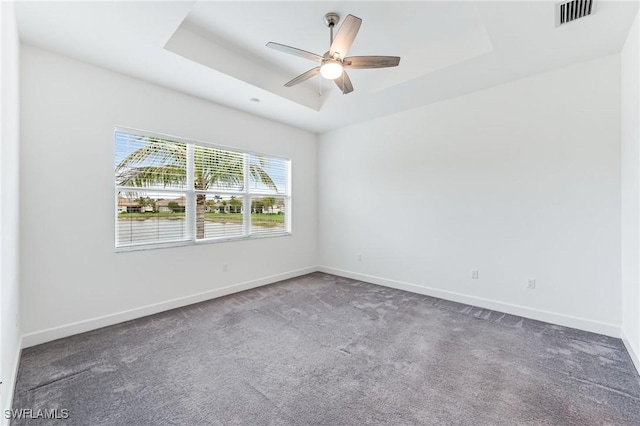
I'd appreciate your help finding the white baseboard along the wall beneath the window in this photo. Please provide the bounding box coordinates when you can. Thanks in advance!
[22,266,318,348]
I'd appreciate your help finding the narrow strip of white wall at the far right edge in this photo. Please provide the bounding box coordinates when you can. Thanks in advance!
[620,8,640,371]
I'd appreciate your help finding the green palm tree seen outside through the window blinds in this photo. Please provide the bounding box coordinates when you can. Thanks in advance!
[116,137,277,239]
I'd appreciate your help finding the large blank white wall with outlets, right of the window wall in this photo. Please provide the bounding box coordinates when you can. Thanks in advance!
[318,55,621,335]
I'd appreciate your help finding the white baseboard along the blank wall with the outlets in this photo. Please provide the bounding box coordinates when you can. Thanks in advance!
[318,266,620,338]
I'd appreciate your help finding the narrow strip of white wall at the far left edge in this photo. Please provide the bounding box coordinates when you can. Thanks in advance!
[0,2,20,424]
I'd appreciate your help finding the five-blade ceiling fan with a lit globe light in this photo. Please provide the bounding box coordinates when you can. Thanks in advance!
[267,12,400,95]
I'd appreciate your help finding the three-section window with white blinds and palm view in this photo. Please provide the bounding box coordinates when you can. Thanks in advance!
[115,130,291,248]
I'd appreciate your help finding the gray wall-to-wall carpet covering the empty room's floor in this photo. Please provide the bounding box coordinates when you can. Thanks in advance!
[12,273,640,425]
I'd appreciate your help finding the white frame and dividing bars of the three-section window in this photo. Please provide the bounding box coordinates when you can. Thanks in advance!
[112,126,293,252]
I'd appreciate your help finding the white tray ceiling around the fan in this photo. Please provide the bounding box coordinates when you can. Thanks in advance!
[16,0,638,133]
